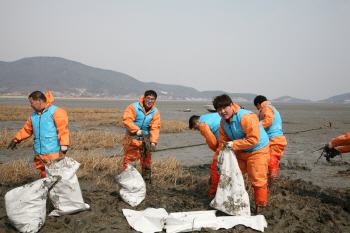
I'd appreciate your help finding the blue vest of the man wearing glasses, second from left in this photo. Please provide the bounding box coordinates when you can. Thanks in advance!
[125,102,157,140]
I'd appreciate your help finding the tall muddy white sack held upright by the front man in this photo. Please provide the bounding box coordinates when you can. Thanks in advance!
[210,149,250,216]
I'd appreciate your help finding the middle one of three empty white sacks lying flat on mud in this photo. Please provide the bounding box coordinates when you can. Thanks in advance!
[165,210,218,233]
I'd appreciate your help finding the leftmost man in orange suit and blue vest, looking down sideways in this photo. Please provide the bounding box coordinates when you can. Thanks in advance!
[7,91,69,178]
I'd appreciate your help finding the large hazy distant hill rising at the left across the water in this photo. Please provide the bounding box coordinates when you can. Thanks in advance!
[0,57,255,101]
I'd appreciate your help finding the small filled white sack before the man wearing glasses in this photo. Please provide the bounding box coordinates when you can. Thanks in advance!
[116,163,146,207]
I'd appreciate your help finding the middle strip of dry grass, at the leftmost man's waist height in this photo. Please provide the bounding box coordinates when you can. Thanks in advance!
[0,128,124,150]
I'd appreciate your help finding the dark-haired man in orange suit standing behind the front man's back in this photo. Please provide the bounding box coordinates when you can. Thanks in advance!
[254,95,287,185]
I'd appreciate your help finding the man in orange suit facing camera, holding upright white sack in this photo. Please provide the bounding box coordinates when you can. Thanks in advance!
[213,94,270,213]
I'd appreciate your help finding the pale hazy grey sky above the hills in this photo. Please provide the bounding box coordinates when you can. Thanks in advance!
[0,0,350,100]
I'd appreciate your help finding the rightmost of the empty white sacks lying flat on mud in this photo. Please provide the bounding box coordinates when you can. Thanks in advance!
[217,215,267,232]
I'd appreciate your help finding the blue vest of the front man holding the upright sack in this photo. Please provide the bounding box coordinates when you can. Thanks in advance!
[222,109,269,152]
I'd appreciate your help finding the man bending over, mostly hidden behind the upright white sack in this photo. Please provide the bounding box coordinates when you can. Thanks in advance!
[189,113,221,197]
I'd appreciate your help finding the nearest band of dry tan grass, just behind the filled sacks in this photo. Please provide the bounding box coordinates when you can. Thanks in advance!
[0,150,254,198]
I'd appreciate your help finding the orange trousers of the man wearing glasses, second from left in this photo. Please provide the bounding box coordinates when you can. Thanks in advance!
[123,134,152,172]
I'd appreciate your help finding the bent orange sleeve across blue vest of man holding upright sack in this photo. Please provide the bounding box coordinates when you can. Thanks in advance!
[233,113,260,150]
